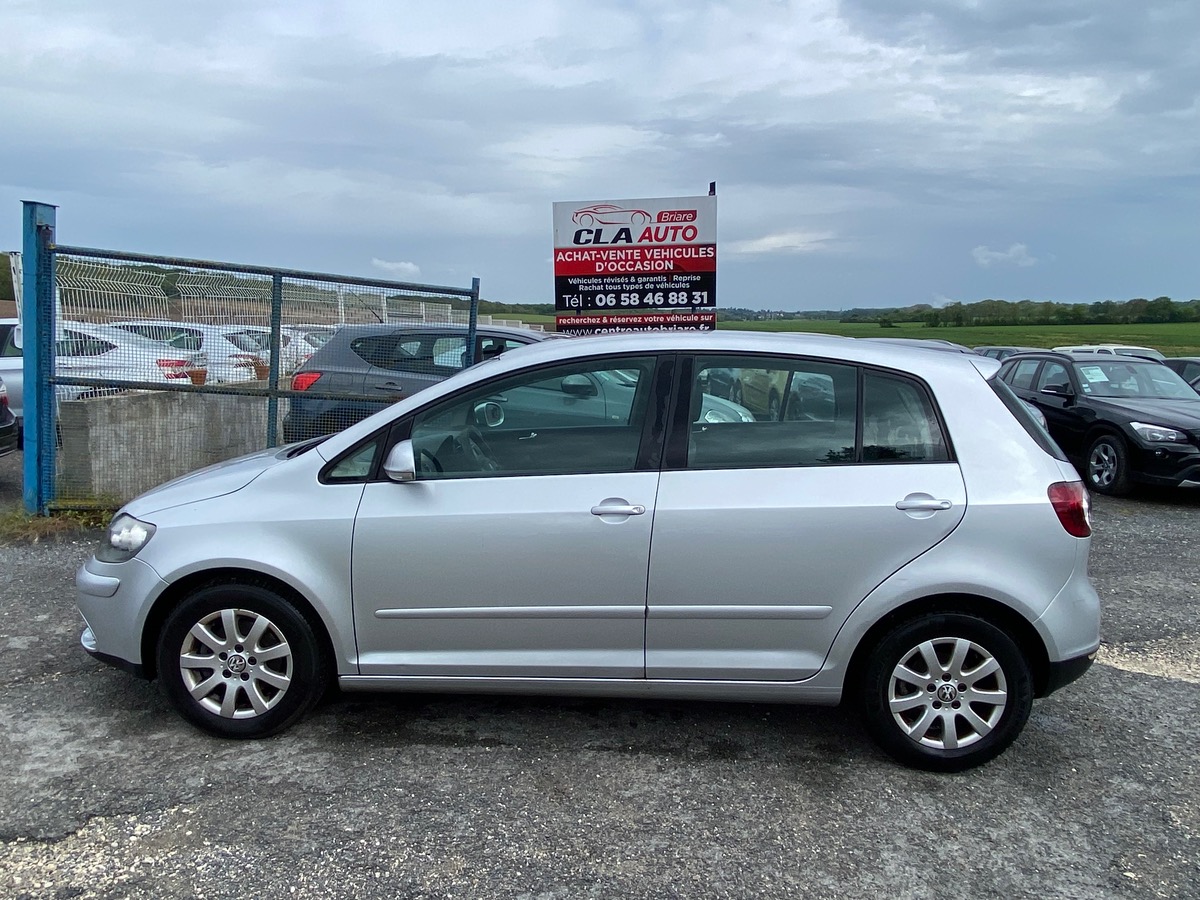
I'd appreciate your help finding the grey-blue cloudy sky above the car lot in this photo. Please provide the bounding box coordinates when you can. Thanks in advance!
[0,0,1200,310]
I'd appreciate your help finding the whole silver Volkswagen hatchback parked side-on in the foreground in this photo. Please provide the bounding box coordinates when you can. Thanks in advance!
[77,331,1099,770]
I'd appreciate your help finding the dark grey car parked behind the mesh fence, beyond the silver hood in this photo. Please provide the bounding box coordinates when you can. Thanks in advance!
[283,323,557,442]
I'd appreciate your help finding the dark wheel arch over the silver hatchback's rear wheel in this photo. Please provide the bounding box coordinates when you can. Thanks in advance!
[842,594,1050,700]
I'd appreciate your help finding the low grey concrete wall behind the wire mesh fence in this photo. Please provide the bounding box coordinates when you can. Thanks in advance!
[58,383,286,504]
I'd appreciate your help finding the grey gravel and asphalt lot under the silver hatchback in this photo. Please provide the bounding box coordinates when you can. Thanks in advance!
[0,455,1200,900]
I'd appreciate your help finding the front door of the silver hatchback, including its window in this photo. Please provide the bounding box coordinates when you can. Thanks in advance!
[352,356,667,678]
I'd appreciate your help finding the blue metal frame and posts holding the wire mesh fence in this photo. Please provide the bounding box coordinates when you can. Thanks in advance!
[18,200,479,515]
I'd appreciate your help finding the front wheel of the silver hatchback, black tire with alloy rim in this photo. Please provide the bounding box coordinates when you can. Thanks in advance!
[156,584,328,738]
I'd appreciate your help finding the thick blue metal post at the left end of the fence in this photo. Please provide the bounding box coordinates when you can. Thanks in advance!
[20,200,58,516]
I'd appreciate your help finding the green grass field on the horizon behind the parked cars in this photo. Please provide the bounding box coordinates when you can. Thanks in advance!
[521,316,1200,356]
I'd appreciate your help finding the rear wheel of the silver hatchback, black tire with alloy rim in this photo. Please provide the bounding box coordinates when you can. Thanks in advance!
[859,612,1033,772]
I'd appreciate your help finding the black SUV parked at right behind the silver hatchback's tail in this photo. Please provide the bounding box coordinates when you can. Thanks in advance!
[1000,350,1200,494]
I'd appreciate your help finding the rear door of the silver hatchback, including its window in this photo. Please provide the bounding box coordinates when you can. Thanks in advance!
[646,356,966,680]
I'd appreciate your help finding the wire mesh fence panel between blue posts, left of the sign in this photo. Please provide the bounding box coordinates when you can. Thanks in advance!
[42,247,540,506]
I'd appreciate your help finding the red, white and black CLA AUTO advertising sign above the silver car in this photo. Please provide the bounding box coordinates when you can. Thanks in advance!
[554,196,716,332]
